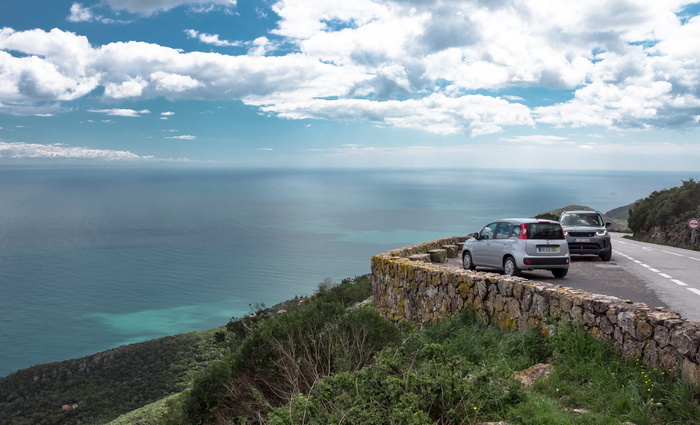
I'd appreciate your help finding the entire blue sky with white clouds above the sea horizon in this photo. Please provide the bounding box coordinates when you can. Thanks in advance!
[0,0,700,171]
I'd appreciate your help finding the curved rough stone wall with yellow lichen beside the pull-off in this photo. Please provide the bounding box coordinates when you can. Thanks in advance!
[372,237,700,384]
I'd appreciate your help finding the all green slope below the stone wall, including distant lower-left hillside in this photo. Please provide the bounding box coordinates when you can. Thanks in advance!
[6,276,700,425]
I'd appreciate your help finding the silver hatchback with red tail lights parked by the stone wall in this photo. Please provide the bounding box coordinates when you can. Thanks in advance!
[462,218,570,277]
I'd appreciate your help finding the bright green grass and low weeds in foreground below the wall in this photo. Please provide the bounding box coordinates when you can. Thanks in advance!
[267,312,700,425]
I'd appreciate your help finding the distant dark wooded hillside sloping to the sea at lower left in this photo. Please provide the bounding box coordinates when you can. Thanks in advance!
[0,329,223,425]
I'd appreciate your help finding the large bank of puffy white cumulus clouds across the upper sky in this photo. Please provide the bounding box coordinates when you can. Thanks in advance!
[0,0,700,136]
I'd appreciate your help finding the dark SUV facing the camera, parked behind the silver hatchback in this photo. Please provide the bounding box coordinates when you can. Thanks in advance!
[559,211,612,261]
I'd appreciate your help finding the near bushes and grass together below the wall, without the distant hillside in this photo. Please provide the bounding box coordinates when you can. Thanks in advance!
[155,279,700,425]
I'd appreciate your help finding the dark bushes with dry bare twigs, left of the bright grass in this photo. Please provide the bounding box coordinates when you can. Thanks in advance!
[160,276,400,424]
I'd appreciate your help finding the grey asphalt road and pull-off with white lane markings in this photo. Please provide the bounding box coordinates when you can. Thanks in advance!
[450,233,700,322]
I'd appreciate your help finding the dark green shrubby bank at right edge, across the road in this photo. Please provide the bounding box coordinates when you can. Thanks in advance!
[628,178,700,235]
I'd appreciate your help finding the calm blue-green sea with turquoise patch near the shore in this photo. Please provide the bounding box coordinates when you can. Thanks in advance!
[0,168,697,376]
